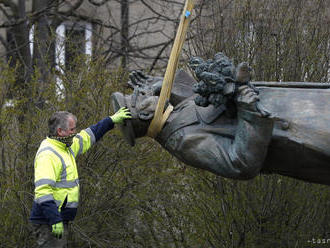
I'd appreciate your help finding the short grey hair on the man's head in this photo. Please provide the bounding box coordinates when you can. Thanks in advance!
[48,111,77,136]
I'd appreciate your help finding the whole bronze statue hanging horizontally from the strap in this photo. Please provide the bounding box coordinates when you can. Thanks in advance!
[111,53,330,185]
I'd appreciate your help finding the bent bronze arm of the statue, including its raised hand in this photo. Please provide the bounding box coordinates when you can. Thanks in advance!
[165,86,273,180]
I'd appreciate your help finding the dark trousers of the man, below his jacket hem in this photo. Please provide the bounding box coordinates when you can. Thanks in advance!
[32,223,69,248]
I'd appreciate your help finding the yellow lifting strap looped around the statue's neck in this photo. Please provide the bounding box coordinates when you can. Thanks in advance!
[147,0,194,138]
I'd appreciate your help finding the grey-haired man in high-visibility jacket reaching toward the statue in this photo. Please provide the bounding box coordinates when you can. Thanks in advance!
[30,108,131,247]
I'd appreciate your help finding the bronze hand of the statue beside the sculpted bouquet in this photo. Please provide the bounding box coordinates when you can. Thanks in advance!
[236,85,259,111]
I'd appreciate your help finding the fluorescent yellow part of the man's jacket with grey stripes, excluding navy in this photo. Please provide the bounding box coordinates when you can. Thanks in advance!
[34,128,95,209]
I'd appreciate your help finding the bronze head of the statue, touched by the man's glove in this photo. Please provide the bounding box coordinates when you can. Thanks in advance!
[110,88,159,146]
